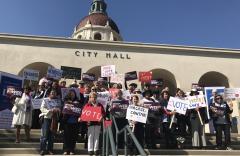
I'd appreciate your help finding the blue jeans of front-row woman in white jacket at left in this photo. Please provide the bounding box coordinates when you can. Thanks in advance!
[40,119,53,151]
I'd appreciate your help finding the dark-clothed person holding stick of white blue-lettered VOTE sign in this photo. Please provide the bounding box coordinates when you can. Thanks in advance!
[160,90,177,149]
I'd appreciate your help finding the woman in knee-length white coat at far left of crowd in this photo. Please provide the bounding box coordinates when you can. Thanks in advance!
[12,87,32,143]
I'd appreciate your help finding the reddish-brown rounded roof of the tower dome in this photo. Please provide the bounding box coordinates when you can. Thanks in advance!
[76,13,119,34]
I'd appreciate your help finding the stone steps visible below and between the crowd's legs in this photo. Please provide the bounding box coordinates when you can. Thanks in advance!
[0,129,240,156]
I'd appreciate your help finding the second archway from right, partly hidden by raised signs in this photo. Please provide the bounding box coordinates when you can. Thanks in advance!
[151,68,177,95]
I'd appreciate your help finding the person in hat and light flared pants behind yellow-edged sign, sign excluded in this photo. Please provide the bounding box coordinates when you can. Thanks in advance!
[189,89,207,149]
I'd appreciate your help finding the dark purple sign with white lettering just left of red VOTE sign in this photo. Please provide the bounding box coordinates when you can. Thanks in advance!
[62,102,82,116]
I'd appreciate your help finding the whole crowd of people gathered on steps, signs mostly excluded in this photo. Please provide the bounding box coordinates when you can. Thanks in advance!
[12,79,233,155]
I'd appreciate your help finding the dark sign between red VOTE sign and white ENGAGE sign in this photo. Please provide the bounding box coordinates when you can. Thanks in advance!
[111,99,129,118]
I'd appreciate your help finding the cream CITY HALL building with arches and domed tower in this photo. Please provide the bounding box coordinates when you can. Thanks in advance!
[0,0,240,91]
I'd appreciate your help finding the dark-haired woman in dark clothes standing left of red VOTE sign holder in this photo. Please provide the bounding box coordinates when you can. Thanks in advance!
[62,89,83,155]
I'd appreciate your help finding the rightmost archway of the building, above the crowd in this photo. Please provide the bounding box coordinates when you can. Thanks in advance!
[198,71,229,88]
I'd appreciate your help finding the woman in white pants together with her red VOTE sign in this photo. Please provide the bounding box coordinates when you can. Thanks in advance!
[79,92,105,155]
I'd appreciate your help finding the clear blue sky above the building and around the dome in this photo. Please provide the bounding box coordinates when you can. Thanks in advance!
[0,0,240,49]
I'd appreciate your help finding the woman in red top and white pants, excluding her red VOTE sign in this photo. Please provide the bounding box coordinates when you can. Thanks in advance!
[78,92,106,155]
